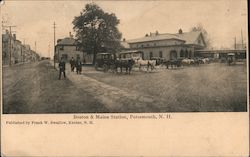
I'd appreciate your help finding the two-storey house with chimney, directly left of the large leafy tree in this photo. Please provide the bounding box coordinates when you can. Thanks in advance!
[56,33,83,62]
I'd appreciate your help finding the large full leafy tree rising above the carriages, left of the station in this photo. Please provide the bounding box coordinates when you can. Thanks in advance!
[72,3,122,64]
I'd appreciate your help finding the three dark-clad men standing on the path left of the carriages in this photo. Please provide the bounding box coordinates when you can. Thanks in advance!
[59,57,85,80]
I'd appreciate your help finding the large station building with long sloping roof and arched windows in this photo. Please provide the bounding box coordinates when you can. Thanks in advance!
[127,29,206,60]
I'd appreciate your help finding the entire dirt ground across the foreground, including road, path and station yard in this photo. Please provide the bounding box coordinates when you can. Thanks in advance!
[3,60,247,113]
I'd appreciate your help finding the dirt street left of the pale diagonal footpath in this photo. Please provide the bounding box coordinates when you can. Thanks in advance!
[3,61,108,113]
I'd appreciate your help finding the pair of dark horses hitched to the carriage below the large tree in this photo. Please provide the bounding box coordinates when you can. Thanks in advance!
[114,59,135,74]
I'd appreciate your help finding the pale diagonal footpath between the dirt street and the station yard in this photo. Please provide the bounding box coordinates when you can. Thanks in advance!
[52,60,160,112]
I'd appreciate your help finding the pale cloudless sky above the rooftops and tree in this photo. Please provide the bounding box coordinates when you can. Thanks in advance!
[0,0,248,56]
